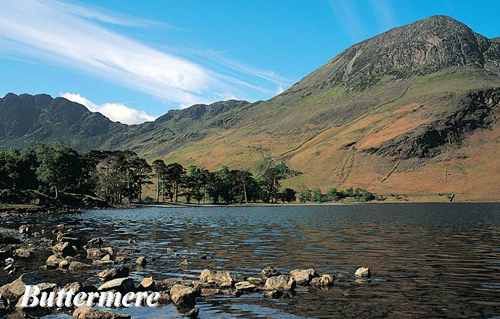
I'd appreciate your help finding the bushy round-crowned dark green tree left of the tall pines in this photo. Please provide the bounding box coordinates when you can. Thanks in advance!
[36,143,82,199]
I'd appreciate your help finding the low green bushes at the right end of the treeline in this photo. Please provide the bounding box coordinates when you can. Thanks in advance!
[299,187,380,203]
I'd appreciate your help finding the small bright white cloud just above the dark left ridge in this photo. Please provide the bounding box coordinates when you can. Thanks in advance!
[61,93,155,124]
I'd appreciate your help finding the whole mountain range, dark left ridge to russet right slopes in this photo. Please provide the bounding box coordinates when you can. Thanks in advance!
[0,16,500,200]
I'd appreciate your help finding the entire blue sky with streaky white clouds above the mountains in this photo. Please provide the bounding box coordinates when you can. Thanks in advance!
[0,0,500,124]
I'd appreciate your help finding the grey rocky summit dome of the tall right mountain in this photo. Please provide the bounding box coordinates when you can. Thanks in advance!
[285,15,500,95]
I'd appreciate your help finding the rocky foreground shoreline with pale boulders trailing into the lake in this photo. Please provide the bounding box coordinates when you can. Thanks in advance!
[0,224,371,318]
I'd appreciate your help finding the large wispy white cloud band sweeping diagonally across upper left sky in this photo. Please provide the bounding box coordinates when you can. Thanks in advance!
[0,0,290,115]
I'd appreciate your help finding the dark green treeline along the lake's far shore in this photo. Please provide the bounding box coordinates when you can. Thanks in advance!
[0,143,382,210]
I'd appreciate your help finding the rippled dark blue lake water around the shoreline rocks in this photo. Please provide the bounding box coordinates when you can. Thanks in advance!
[9,203,500,318]
